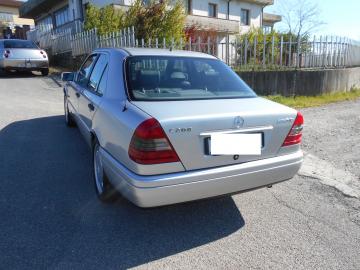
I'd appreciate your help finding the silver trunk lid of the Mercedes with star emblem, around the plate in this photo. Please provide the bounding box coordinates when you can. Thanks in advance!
[133,97,297,170]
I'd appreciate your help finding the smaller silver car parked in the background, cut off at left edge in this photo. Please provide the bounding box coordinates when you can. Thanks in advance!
[0,39,49,76]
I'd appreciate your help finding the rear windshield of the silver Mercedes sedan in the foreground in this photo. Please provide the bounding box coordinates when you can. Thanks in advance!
[126,56,256,101]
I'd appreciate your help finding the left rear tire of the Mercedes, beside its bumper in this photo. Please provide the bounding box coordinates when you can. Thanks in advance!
[93,141,118,203]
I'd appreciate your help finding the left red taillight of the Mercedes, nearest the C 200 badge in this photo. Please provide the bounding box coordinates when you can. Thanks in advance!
[129,118,180,165]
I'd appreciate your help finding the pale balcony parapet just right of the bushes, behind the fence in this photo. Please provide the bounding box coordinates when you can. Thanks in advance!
[186,15,240,34]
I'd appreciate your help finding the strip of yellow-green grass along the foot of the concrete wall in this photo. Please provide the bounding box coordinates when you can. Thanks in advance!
[265,89,360,109]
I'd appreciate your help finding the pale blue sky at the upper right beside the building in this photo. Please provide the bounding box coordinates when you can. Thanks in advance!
[265,0,360,40]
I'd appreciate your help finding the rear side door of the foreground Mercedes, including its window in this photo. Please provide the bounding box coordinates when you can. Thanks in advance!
[79,53,108,146]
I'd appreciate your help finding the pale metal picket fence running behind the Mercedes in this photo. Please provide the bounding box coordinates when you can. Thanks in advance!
[28,27,360,69]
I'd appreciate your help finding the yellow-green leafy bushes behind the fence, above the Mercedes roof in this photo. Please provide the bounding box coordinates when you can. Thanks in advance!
[85,0,186,42]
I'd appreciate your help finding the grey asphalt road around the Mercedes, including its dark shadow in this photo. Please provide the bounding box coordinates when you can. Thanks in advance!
[0,72,360,269]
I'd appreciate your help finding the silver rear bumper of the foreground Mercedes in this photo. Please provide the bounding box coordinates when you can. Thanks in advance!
[102,150,303,207]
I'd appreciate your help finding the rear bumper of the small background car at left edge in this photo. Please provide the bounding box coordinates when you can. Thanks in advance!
[0,59,49,70]
